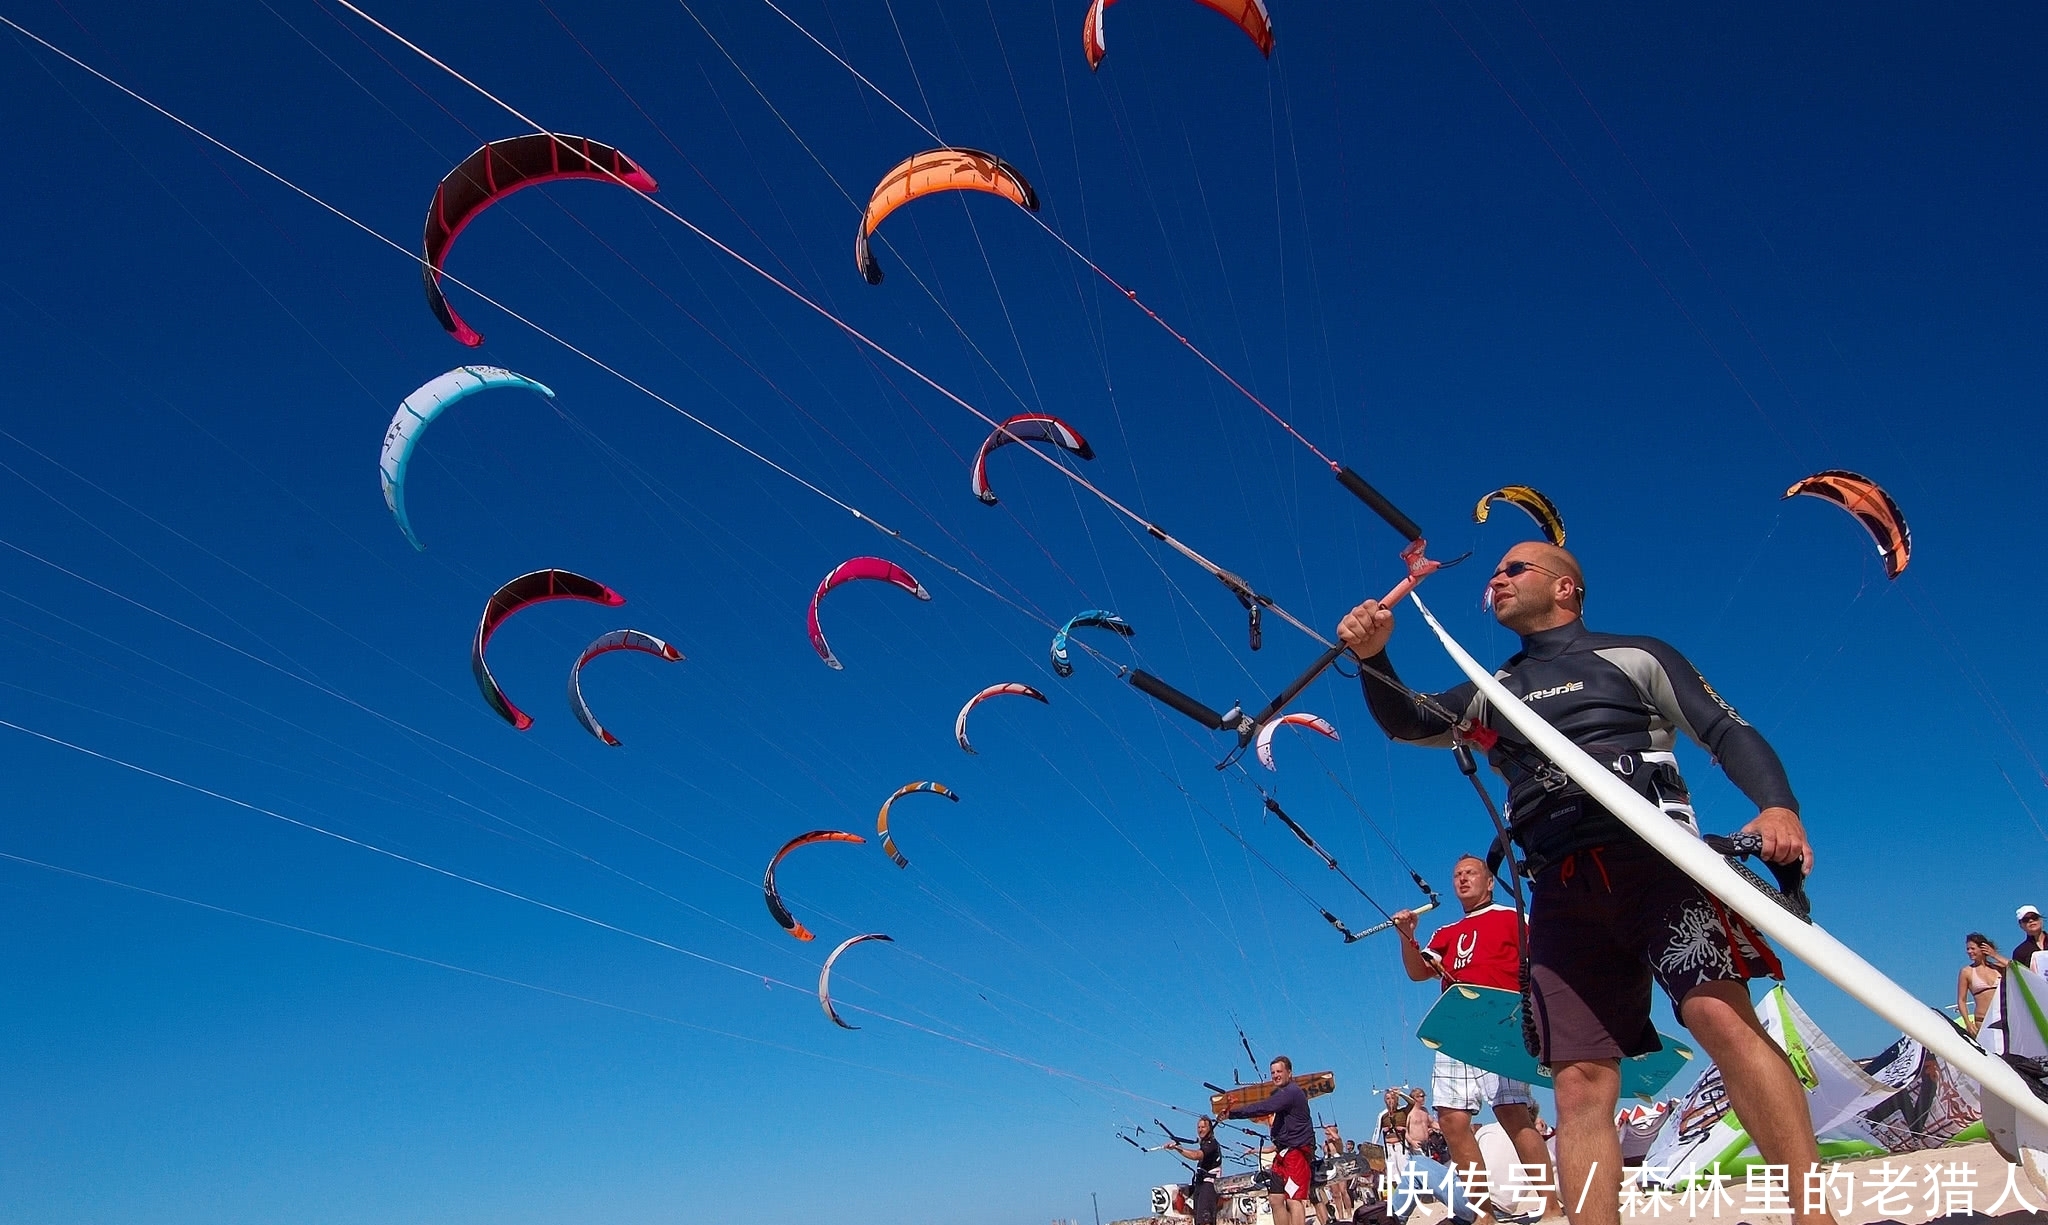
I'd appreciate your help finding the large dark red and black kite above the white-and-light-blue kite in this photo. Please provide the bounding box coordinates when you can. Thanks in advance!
[420,131,655,348]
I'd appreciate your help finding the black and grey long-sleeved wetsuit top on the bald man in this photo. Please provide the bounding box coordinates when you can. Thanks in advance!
[1364,621,1798,862]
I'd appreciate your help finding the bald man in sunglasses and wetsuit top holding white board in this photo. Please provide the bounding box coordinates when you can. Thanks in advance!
[1337,543,1827,1225]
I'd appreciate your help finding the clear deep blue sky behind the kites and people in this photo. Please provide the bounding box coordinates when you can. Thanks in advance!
[0,0,2048,1223]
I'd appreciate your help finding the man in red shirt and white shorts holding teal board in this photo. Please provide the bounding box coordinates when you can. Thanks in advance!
[1393,854,1565,1225]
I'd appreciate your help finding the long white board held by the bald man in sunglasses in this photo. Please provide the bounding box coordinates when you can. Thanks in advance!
[1409,592,2048,1127]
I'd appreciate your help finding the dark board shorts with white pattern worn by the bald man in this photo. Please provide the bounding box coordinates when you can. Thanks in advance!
[1530,838,1784,1065]
